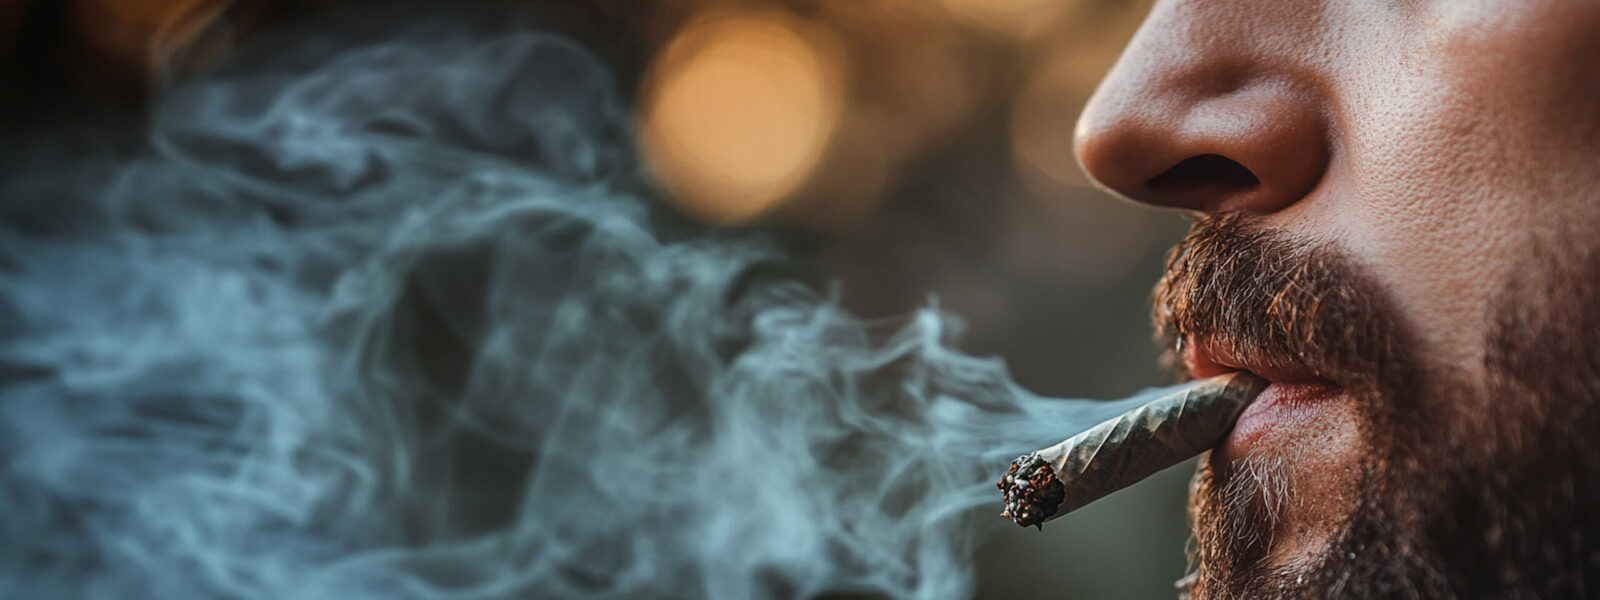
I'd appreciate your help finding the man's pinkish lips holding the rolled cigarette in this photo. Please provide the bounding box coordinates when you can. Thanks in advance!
[1179,336,1342,461]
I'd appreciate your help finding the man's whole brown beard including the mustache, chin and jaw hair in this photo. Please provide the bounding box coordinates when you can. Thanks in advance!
[1155,216,1600,598]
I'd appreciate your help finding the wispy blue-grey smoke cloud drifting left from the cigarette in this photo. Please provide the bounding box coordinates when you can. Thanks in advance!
[0,10,1177,600]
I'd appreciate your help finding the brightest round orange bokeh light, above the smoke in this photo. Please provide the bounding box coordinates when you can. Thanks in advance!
[642,13,843,224]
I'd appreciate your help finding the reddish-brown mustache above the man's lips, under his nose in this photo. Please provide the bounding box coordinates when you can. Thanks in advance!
[1152,213,1405,394]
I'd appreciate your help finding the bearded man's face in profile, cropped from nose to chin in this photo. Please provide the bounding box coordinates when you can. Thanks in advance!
[1077,0,1600,595]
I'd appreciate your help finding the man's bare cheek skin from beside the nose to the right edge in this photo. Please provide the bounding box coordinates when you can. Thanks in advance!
[1314,0,1600,387]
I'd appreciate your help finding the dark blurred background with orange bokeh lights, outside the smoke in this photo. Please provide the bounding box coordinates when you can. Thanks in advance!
[0,0,1192,598]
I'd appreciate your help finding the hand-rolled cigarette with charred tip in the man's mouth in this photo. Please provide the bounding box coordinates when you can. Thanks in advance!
[998,373,1267,528]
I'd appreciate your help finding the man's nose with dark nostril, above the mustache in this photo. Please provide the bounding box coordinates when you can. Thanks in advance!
[1075,0,1330,214]
